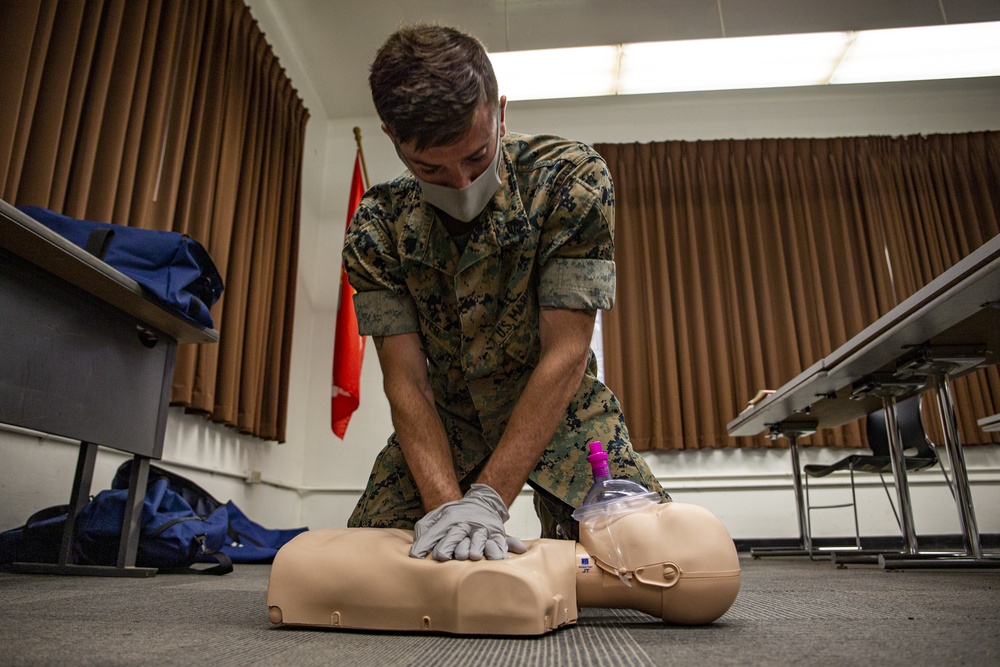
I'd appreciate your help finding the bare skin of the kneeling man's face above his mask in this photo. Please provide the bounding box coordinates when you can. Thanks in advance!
[382,96,507,190]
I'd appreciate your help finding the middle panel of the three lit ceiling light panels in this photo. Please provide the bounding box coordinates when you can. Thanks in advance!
[618,32,851,95]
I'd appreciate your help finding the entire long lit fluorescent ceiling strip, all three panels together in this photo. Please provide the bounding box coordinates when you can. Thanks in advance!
[490,22,1000,100]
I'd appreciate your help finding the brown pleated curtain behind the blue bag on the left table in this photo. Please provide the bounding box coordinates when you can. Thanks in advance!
[0,0,308,441]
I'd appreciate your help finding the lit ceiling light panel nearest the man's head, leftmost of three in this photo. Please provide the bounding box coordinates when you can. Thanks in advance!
[490,46,621,100]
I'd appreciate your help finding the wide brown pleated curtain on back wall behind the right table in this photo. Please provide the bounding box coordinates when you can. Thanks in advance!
[596,133,1000,450]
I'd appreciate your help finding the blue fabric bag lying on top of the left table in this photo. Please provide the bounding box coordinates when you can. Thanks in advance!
[17,206,223,329]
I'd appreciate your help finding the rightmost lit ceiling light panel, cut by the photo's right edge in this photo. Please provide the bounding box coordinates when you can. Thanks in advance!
[830,23,1000,83]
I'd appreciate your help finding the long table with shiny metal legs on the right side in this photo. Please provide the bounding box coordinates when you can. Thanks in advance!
[727,236,1000,569]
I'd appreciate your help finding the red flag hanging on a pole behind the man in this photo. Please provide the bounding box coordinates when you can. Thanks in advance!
[330,154,365,439]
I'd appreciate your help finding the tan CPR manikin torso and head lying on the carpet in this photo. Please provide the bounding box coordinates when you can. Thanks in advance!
[267,502,740,635]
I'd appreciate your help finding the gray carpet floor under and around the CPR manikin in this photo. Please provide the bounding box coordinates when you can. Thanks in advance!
[0,557,1000,667]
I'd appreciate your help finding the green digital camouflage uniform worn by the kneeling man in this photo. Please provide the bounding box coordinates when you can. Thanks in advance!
[344,133,666,537]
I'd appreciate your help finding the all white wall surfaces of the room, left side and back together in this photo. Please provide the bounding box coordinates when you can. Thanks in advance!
[0,13,1000,538]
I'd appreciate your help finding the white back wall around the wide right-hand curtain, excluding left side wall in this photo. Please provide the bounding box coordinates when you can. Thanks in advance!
[312,79,1000,538]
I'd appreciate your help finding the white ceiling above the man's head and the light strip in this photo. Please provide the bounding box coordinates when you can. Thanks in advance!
[248,0,1000,118]
